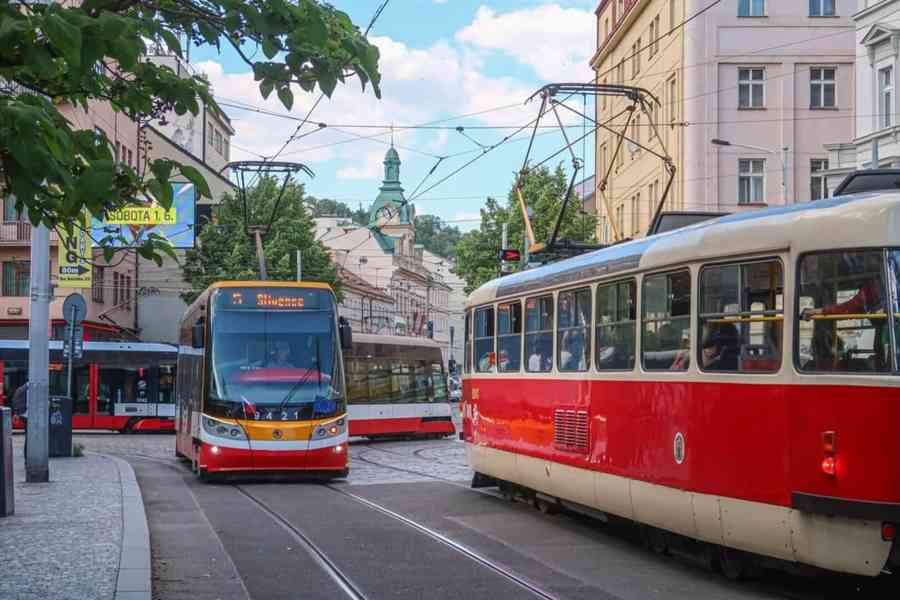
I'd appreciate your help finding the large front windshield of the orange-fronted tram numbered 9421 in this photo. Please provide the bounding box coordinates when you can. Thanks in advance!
[206,289,345,421]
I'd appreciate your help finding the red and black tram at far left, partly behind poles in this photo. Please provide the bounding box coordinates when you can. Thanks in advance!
[0,340,178,433]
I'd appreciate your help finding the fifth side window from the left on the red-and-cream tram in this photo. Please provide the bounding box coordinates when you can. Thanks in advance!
[596,280,637,371]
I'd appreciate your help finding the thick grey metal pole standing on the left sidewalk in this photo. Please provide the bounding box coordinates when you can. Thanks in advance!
[25,225,52,483]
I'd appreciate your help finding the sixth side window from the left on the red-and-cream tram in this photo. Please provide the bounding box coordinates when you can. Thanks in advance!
[641,271,691,371]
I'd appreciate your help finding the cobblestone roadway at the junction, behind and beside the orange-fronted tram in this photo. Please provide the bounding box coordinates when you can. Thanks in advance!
[74,433,472,485]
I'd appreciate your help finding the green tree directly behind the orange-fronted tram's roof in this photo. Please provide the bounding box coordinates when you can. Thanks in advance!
[182,178,341,302]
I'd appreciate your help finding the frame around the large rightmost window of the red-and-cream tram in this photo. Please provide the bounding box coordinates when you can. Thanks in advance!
[791,245,900,377]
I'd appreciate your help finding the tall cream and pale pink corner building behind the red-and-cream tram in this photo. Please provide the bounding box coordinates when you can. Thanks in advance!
[592,0,856,242]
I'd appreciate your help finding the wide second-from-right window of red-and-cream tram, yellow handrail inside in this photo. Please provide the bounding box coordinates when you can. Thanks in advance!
[697,260,784,373]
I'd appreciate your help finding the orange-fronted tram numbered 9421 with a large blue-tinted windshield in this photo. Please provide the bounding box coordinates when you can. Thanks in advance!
[175,281,352,479]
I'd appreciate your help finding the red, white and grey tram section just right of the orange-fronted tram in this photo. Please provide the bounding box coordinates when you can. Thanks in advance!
[344,334,456,438]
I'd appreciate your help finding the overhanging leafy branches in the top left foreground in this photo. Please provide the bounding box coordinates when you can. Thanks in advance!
[0,0,380,257]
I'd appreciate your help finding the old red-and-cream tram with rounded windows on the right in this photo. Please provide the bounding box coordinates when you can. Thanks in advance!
[462,193,900,576]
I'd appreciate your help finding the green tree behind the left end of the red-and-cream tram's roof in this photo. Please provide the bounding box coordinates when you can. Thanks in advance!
[454,166,597,294]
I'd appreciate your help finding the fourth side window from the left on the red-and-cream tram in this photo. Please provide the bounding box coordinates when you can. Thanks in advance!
[556,288,591,371]
